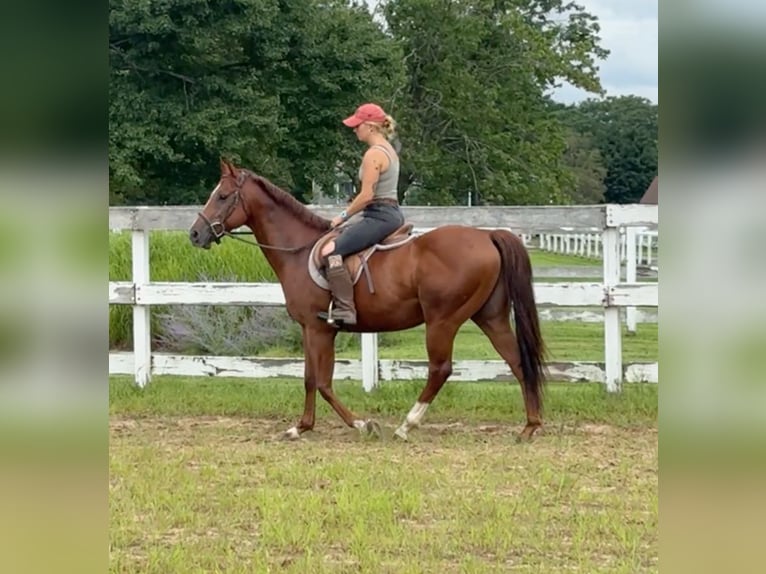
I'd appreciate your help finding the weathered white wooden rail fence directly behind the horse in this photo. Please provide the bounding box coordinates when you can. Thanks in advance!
[109,205,658,391]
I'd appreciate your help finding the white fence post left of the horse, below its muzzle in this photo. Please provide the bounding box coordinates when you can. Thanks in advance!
[131,229,152,387]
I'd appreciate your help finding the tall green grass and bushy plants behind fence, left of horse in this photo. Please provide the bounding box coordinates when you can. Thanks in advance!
[109,231,359,356]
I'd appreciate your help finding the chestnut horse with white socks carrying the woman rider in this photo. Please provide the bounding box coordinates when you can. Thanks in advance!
[189,159,547,441]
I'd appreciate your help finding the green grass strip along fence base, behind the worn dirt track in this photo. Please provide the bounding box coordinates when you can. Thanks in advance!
[109,376,657,426]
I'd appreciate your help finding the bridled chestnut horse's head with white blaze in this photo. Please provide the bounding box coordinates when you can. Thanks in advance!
[189,159,247,249]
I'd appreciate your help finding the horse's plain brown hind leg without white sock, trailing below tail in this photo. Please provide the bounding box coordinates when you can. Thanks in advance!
[473,316,542,439]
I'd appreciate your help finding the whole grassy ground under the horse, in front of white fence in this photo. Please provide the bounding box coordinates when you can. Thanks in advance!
[109,377,658,574]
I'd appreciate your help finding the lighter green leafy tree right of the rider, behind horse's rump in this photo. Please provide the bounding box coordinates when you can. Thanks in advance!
[383,0,607,204]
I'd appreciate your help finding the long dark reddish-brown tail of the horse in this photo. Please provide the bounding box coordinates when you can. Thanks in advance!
[489,229,546,410]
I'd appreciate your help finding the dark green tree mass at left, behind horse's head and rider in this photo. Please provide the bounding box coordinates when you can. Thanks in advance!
[109,0,402,203]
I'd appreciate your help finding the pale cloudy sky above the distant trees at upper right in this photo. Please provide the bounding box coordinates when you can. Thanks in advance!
[553,0,658,104]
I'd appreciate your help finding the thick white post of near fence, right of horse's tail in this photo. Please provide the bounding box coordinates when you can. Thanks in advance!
[602,227,622,392]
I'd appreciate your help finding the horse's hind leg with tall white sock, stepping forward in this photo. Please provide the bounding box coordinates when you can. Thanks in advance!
[394,323,460,440]
